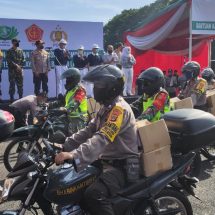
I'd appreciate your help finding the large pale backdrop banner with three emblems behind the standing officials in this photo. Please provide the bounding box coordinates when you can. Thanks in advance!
[0,19,103,99]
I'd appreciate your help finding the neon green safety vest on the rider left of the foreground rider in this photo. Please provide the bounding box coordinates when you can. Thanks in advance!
[65,86,87,117]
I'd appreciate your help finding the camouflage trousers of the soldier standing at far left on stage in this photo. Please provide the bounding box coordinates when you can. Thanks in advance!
[8,68,23,97]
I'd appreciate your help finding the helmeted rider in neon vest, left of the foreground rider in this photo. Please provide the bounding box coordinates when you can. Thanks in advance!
[49,68,88,134]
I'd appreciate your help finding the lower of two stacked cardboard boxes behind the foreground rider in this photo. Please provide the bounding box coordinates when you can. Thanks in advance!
[141,145,173,177]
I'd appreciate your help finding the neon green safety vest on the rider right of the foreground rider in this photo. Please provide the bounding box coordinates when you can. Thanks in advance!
[143,91,170,122]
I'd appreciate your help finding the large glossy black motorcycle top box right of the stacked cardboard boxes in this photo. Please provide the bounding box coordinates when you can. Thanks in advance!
[163,109,215,151]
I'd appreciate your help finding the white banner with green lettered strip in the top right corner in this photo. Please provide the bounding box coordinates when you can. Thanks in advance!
[192,0,215,35]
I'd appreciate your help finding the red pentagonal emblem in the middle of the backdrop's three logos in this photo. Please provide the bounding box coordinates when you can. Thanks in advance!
[25,24,43,42]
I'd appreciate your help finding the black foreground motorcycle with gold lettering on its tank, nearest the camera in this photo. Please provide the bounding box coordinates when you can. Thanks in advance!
[0,140,198,215]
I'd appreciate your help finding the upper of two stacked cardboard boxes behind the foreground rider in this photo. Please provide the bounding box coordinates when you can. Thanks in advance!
[137,119,171,153]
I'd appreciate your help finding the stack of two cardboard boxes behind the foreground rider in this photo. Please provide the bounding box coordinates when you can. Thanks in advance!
[136,120,172,177]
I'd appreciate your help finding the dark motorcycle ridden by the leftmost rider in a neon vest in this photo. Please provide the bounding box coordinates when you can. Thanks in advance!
[3,106,69,171]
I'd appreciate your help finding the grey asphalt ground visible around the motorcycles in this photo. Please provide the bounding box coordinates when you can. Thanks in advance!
[0,142,215,215]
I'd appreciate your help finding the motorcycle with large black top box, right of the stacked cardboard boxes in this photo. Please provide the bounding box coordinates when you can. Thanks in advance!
[163,109,215,177]
